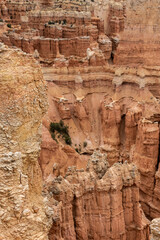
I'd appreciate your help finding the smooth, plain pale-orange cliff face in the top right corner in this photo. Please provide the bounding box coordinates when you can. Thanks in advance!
[115,0,160,66]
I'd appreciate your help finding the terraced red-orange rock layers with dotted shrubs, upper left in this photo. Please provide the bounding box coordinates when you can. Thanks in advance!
[0,0,112,65]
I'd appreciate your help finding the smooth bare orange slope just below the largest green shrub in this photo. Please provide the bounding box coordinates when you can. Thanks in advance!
[39,126,87,181]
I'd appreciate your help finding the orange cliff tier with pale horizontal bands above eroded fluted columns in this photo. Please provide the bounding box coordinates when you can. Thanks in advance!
[42,66,160,222]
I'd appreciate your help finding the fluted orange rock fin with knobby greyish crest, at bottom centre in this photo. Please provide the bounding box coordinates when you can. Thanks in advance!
[49,152,149,240]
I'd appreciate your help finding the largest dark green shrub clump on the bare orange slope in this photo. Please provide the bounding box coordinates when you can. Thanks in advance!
[50,120,72,145]
